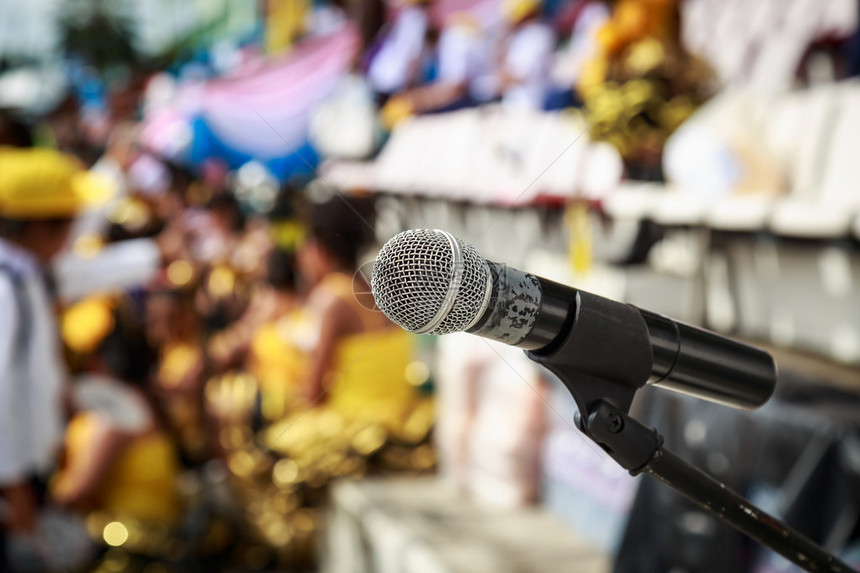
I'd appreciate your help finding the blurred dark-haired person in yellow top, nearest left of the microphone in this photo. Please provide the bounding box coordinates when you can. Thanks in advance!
[298,196,415,429]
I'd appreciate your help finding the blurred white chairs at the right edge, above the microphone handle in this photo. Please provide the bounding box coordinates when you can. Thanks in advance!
[604,81,860,238]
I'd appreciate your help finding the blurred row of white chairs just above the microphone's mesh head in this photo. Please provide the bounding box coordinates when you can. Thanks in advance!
[322,106,623,206]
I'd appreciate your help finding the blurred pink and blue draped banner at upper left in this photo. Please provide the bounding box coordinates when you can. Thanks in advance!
[142,26,358,179]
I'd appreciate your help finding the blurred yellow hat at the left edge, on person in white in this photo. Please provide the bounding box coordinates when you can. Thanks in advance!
[0,147,113,219]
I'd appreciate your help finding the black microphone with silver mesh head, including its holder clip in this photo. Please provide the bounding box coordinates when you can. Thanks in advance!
[370,229,777,412]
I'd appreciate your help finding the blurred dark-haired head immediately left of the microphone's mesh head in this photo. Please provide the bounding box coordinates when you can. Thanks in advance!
[298,195,374,284]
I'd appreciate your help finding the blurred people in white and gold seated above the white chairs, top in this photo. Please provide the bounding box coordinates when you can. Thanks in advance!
[296,0,717,179]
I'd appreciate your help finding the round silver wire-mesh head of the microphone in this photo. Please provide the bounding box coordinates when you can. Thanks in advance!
[370,229,492,334]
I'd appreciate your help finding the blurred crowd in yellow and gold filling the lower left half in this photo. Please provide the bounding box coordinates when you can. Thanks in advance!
[0,118,435,571]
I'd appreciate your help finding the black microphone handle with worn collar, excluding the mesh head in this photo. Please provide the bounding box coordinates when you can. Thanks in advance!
[468,261,777,409]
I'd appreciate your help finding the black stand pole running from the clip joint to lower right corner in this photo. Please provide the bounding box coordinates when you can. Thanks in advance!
[580,402,854,573]
